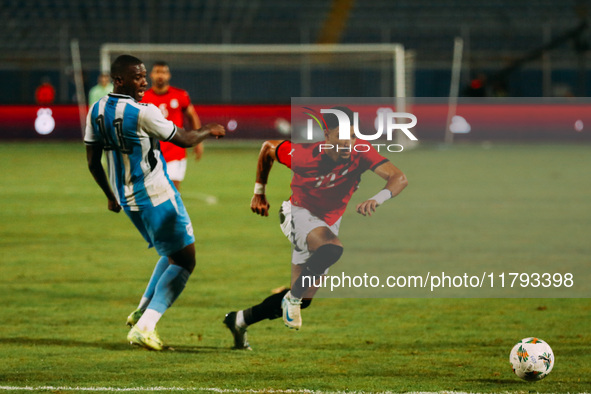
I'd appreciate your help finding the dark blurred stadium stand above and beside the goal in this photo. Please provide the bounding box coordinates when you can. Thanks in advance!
[0,0,585,103]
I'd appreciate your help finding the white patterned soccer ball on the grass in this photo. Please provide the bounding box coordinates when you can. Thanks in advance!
[509,337,554,381]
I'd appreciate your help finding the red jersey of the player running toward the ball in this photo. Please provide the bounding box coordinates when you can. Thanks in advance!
[275,140,388,226]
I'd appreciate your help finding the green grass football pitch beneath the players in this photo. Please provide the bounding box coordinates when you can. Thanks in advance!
[0,141,591,393]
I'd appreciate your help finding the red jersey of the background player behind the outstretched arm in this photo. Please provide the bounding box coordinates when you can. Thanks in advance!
[142,86,191,162]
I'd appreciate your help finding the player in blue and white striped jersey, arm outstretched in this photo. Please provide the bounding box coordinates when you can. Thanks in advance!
[84,55,225,350]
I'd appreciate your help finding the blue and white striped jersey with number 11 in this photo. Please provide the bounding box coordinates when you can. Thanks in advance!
[84,93,177,211]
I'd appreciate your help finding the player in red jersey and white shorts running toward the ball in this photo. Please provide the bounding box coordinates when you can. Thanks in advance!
[224,107,408,349]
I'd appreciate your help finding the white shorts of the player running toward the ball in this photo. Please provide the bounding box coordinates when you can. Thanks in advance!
[280,201,342,264]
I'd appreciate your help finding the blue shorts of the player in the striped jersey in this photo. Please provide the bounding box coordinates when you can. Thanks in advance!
[125,193,195,256]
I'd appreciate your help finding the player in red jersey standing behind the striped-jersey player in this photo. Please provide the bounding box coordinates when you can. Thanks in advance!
[142,61,203,190]
